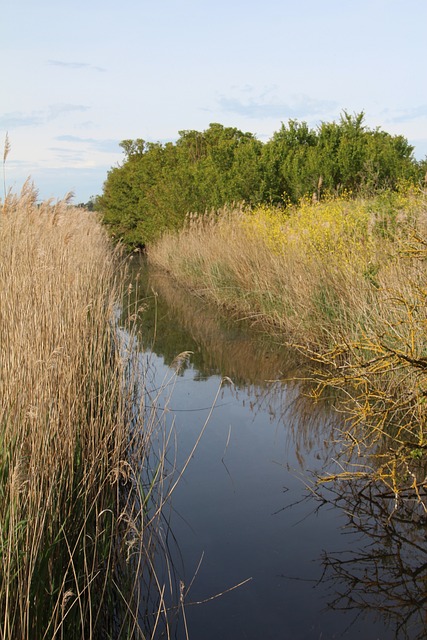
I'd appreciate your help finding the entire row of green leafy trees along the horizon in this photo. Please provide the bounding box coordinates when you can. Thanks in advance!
[96,111,427,248]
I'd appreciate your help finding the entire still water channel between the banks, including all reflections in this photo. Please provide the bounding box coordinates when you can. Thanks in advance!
[122,260,427,640]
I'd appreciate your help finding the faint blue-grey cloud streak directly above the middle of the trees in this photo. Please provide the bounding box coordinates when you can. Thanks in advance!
[219,88,338,120]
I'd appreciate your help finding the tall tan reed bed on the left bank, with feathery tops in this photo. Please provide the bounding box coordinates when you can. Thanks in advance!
[0,183,178,640]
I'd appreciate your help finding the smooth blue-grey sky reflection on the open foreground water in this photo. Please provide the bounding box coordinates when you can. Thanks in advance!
[137,338,392,640]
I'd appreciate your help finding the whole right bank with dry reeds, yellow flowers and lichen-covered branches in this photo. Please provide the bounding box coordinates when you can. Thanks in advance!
[148,188,427,504]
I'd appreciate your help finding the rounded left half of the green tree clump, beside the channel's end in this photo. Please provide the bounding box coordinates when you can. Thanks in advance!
[96,124,262,247]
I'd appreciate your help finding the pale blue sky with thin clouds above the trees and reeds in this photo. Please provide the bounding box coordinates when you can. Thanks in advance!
[0,0,427,204]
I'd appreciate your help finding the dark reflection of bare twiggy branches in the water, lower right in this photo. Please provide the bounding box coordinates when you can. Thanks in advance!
[314,480,427,640]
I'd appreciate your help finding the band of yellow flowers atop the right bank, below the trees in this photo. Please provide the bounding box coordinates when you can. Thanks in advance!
[241,185,422,257]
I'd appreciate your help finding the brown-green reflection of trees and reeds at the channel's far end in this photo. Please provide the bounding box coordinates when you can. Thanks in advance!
[122,255,301,386]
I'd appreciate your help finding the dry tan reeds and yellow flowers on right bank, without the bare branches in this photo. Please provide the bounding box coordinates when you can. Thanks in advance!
[148,191,426,347]
